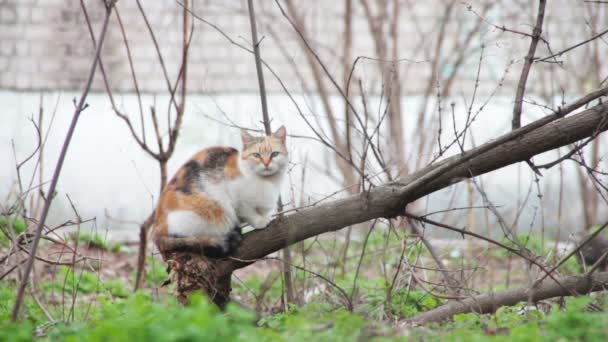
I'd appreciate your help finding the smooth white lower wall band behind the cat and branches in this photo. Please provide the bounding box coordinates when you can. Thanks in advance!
[0,91,605,238]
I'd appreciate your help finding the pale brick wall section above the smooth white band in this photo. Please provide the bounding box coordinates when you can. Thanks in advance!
[0,0,608,94]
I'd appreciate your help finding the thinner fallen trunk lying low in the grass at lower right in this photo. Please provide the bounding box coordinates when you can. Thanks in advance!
[402,272,608,326]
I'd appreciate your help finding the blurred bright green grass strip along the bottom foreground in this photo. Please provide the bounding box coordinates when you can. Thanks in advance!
[0,284,608,342]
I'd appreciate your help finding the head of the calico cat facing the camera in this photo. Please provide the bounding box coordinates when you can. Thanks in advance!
[241,126,289,177]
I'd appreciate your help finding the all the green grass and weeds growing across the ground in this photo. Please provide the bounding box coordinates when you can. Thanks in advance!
[0,227,608,342]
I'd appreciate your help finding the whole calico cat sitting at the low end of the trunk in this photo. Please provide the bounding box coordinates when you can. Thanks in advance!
[153,126,288,258]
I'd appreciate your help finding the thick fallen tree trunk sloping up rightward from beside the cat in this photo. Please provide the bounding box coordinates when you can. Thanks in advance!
[156,99,608,304]
